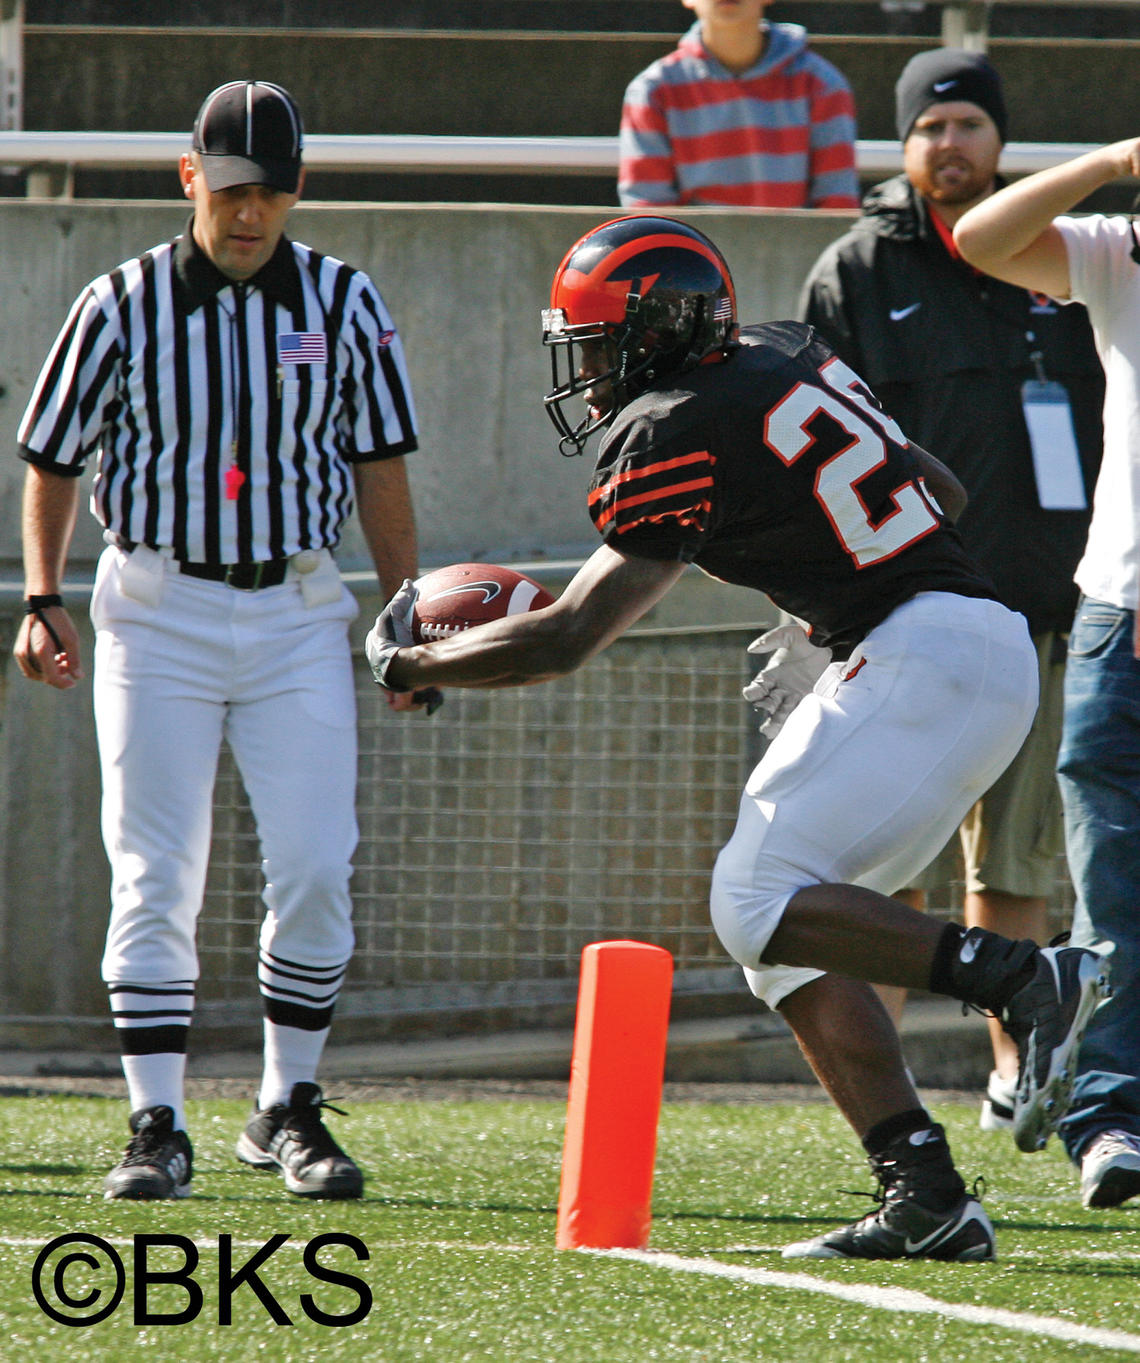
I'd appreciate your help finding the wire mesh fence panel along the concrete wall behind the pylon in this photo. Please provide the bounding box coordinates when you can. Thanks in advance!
[189,628,1072,1040]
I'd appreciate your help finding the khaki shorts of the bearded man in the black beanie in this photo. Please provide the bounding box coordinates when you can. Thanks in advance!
[908,634,1066,898]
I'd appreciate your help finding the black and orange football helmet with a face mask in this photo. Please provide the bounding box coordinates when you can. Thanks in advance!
[543,217,736,455]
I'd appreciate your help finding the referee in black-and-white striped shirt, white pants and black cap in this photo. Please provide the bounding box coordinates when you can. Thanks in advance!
[15,80,416,1198]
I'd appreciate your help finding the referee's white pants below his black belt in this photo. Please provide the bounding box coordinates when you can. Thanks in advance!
[91,549,357,983]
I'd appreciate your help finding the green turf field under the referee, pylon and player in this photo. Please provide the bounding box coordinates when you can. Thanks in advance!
[0,1086,1140,1363]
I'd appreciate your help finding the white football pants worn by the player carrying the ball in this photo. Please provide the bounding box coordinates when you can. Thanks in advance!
[712,592,1038,1007]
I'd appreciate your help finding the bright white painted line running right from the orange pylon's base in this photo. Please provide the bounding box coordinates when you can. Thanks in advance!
[597,1250,1140,1353]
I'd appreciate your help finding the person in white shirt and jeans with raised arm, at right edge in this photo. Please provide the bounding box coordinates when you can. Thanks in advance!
[955,138,1140,1206]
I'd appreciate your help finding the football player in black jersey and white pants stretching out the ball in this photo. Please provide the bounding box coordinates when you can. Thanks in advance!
[367,217,1107,1261]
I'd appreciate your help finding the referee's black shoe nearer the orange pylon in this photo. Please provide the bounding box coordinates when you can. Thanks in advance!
[236,1084,364,1199]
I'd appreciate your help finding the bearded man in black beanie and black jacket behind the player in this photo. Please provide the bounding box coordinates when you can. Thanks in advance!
[800,48,1103,1130]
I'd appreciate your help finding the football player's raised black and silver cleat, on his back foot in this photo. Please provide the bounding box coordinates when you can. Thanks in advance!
[1001,946,1110,1152]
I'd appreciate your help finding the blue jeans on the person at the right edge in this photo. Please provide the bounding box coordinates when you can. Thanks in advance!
[1057,597,1140,1161]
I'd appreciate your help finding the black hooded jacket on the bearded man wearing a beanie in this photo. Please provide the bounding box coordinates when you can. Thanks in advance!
[800,176,1105,634]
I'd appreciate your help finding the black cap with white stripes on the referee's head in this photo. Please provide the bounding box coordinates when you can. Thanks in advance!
[192,80,301,194]
